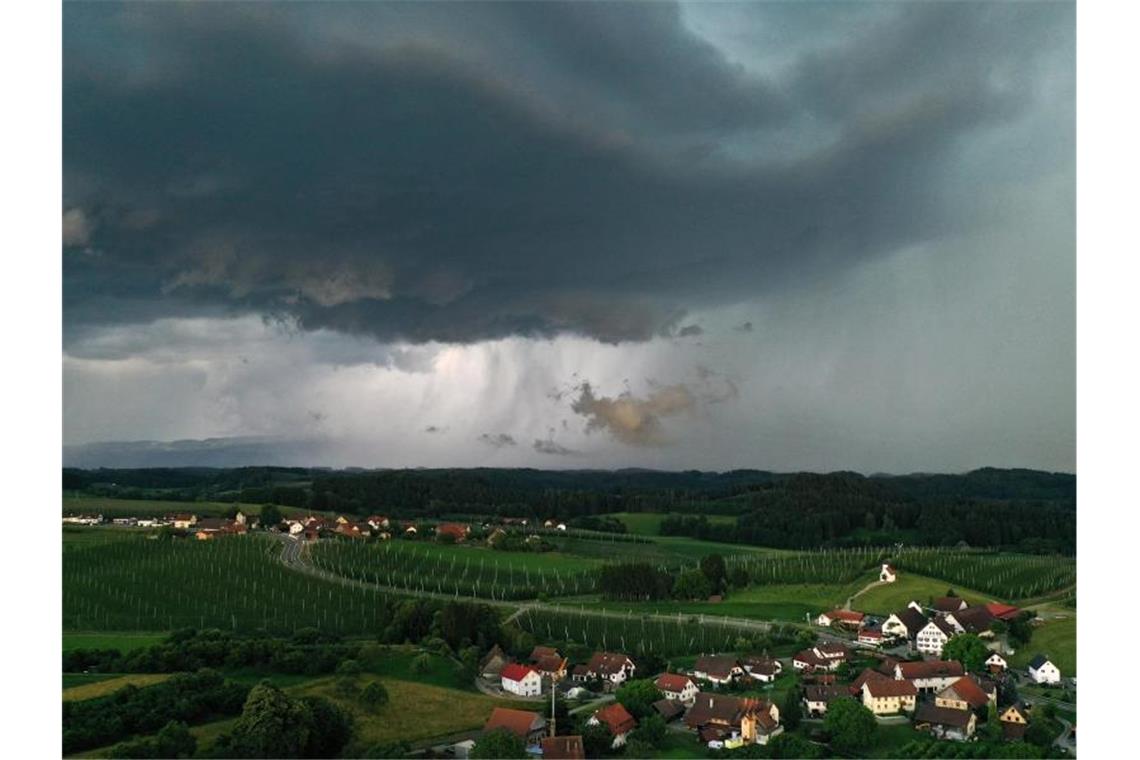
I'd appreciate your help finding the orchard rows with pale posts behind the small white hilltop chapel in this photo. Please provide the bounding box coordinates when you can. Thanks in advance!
[891,548,1076,602]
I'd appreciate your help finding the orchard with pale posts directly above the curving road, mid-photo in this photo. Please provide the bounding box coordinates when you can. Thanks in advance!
[310,540,601,599]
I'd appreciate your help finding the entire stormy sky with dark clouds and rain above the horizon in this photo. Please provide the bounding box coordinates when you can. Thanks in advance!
[62,2,1076,473]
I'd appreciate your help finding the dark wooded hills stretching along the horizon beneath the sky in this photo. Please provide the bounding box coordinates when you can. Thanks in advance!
[63,467,1076,553]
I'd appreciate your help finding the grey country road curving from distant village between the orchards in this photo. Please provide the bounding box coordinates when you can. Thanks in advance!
[270,533,802,644]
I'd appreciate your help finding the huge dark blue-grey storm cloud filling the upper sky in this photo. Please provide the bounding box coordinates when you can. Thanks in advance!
[62,3,1073,342]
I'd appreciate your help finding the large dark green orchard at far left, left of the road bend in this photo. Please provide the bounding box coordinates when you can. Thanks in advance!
[63,533,401,635]
